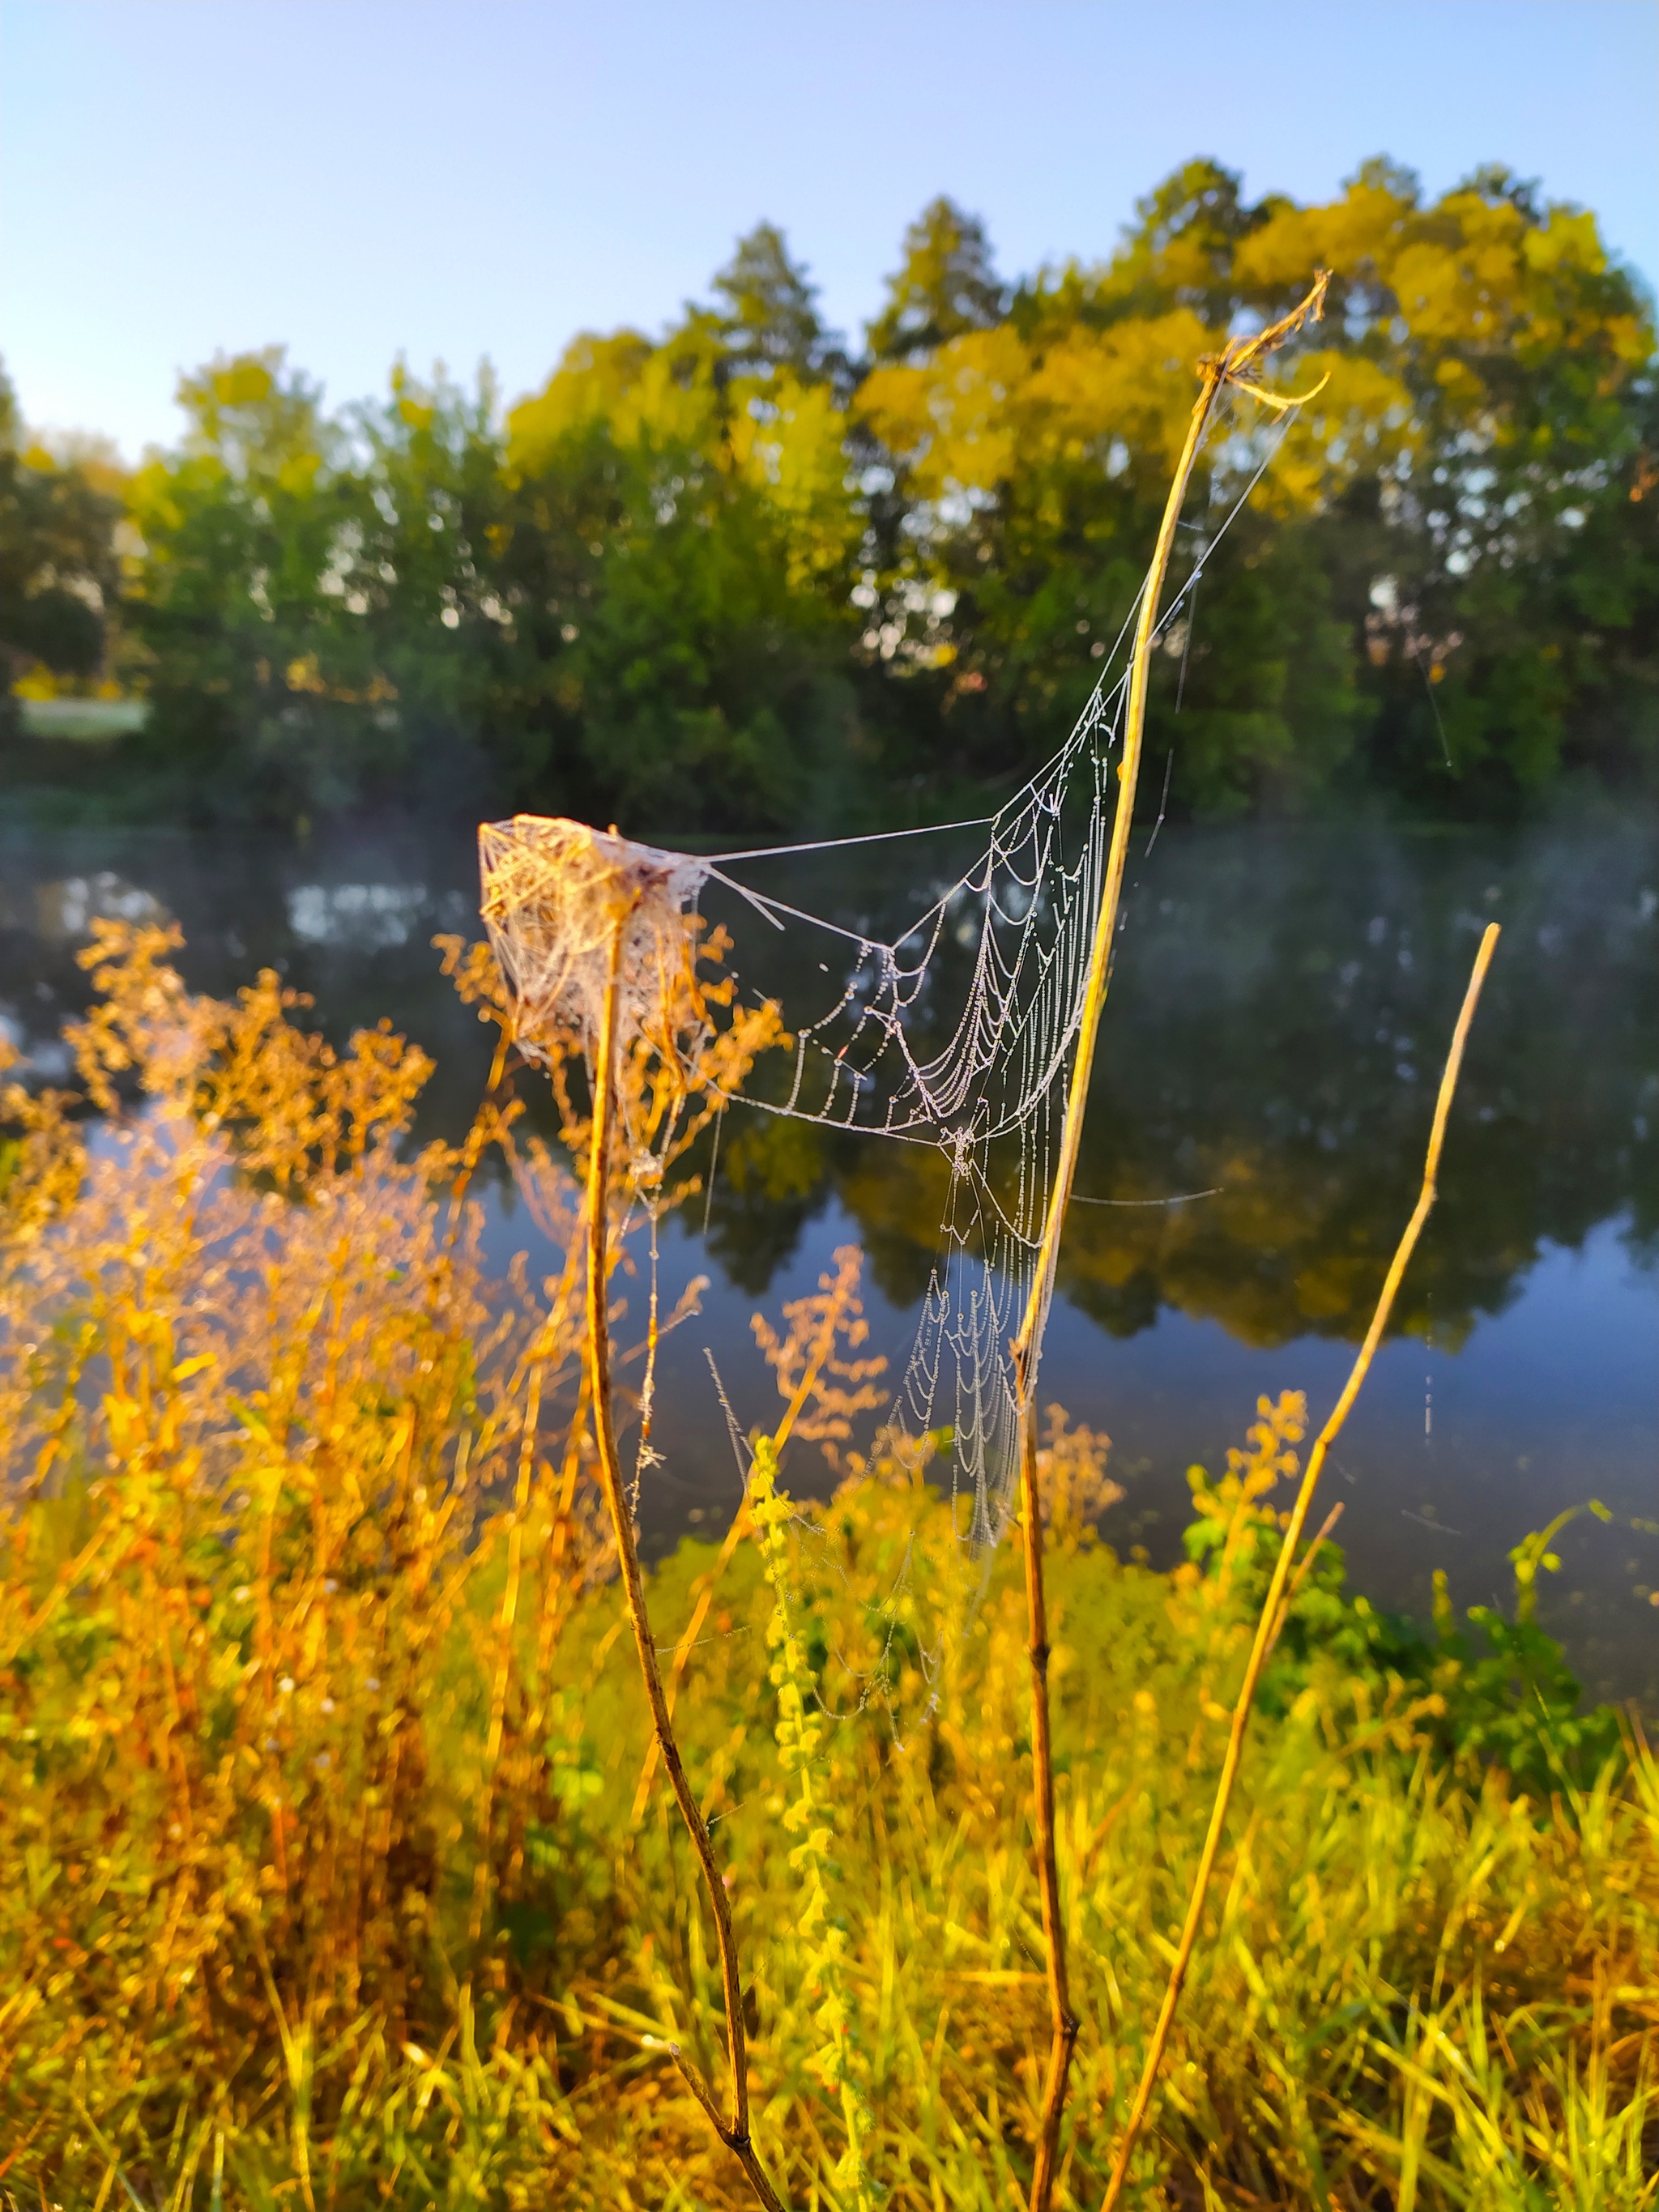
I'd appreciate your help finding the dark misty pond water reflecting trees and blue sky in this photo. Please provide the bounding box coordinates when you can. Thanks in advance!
[0,816,1659,1707]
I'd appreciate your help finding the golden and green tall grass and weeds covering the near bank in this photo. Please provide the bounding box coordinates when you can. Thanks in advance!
[0,929,1659,2212]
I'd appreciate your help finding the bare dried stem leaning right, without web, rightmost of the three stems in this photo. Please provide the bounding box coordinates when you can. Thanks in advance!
[1102,923,1498,2212]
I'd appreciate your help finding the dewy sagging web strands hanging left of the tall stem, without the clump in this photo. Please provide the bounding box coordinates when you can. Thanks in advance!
[710,707,1121,1542]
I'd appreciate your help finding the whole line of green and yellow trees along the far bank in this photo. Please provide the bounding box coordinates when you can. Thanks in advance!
[0,160,1659,832]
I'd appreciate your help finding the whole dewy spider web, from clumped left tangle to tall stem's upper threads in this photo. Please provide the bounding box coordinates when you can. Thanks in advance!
[480,389,1309,1542]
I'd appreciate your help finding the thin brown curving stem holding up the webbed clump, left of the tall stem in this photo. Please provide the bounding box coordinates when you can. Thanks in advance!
[586,907,783,2212]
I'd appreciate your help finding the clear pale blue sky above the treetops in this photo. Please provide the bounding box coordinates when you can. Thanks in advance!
[0,0,1659,458]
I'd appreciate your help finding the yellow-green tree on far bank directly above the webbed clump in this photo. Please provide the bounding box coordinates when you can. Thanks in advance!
[511,307,860,827]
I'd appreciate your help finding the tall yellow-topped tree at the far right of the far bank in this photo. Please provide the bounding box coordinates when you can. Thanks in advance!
[1235,161,1659,810]
